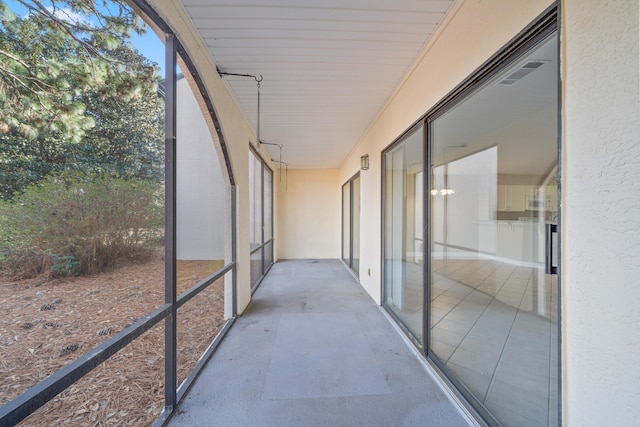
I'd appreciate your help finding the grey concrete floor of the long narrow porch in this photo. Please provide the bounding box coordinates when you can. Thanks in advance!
[169,260,472,427]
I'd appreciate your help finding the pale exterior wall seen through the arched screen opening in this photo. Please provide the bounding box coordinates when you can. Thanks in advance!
[176,78,229,260]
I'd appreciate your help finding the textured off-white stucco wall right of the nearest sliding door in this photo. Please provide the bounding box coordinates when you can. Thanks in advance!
[562,0,640,426]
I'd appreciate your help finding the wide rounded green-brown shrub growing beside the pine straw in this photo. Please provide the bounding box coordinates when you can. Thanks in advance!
[0,172,163,278]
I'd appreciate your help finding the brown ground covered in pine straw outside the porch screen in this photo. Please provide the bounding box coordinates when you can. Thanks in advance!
[0,250,224,426]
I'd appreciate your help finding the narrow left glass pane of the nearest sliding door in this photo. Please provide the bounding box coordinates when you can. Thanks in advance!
[384,128,424,343]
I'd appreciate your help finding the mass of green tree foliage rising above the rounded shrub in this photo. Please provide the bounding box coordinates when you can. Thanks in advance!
[0,0,164,199]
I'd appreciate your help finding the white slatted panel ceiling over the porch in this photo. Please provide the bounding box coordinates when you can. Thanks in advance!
[183,0,453,168]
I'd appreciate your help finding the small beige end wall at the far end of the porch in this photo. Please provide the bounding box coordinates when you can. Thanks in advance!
[274,169,342,259]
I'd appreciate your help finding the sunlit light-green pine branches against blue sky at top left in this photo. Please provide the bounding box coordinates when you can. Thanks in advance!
[0,0,154,137]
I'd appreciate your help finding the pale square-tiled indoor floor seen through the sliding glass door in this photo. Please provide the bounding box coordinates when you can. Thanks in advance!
[388,259,558,426]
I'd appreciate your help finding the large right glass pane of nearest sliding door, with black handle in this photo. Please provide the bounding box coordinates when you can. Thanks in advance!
[429,32,558,425]
